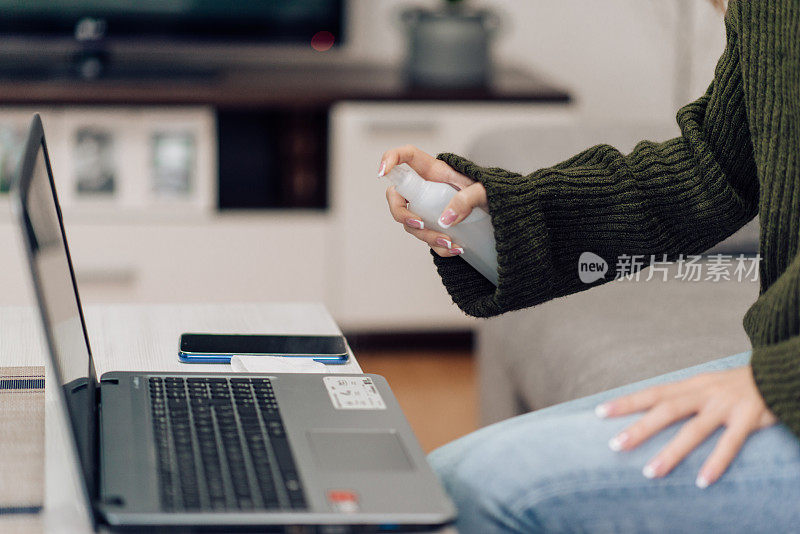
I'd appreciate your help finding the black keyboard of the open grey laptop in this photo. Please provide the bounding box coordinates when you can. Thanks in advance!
[150,377,306,511]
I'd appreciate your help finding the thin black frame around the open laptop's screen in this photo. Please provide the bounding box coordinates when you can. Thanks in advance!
[11,113,99,526]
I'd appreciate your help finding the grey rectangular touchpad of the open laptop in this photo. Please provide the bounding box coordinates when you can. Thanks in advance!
[308,430,413,471]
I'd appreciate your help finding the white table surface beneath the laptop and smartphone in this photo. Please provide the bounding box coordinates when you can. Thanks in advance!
[0,303,361,534]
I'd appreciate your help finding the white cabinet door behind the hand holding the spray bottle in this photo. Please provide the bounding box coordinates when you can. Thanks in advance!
[328,103,575,330]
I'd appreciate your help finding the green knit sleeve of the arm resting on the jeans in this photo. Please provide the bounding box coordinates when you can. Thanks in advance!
[744,253,800,436]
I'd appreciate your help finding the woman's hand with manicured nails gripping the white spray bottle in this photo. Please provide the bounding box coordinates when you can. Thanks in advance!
[378,145,488,257]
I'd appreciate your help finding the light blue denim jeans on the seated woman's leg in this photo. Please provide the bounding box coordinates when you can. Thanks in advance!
[429,352,800,534]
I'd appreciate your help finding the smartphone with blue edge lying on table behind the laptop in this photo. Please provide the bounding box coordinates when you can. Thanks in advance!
[178,334,347,364]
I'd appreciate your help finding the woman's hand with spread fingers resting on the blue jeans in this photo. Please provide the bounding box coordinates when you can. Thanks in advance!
[595,365,777,488]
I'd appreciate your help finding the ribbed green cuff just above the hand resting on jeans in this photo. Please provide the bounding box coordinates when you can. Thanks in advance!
[751,336,800,436]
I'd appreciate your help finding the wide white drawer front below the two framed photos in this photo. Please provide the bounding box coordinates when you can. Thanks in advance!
[0,212,330,305]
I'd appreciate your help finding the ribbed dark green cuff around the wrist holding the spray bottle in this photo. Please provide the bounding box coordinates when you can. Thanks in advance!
[434,154,554,317]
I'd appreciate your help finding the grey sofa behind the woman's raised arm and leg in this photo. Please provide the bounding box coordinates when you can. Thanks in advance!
[470,121,758,424]
